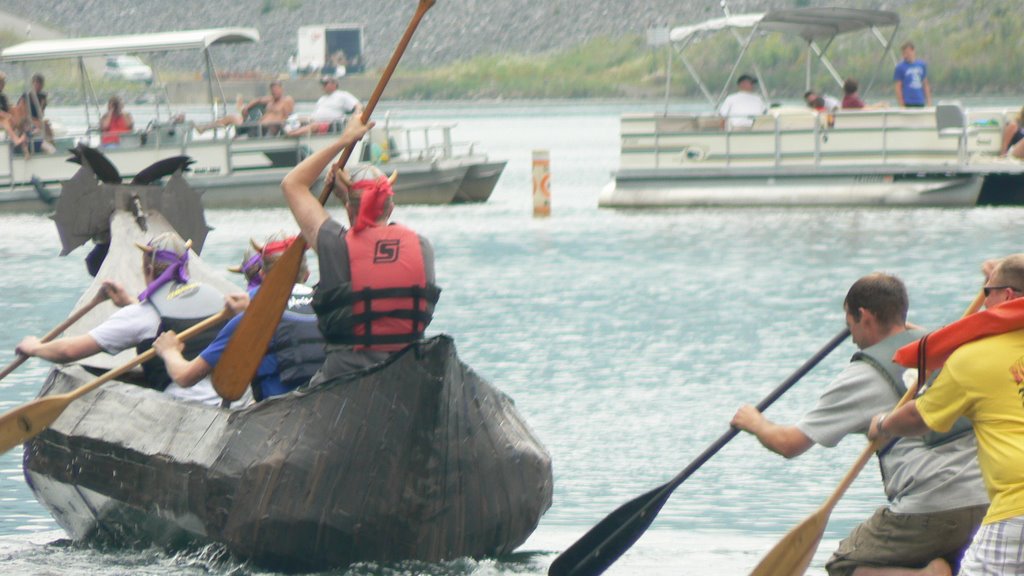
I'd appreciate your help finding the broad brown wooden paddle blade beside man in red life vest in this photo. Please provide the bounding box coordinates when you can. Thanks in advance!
[207,236,306,402]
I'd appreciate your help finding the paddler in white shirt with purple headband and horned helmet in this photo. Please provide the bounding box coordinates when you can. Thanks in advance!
[16,233,247,406]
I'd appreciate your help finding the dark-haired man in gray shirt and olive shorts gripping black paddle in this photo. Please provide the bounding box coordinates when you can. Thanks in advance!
[732,274,988,576]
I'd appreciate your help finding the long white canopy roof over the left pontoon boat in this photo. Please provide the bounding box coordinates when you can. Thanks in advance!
[0,28,259,63]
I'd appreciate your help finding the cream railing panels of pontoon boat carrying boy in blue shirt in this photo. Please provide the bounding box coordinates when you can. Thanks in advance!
[621,109,1010,169]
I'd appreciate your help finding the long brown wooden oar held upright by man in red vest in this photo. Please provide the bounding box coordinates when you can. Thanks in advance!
[213,0,434,402]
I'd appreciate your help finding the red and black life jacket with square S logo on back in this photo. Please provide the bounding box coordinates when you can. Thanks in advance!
[313,224,440,352]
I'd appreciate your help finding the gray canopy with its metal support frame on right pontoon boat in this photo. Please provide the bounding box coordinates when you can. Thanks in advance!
[666,7,899,109]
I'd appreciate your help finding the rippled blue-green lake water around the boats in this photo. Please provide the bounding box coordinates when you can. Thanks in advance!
[0,100,1024,575]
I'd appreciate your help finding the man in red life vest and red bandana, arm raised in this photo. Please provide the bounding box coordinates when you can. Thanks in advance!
[281,116,440,385]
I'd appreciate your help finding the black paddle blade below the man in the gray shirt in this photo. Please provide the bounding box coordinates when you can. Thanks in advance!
[548,482,675,576]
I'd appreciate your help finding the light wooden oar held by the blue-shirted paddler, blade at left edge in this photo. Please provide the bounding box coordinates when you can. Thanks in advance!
[0,310,231,454]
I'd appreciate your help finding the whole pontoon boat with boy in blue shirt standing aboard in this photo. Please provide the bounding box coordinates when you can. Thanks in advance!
[599,8,1024,207]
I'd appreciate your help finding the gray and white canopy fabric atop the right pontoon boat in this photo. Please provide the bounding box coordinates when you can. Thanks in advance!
[670,8,899,42]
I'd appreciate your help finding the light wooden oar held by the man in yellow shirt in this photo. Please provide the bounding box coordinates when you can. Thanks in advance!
[751,291,985,576]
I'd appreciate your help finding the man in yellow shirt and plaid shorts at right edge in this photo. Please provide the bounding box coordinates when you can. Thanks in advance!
[870,254,1024,576]
